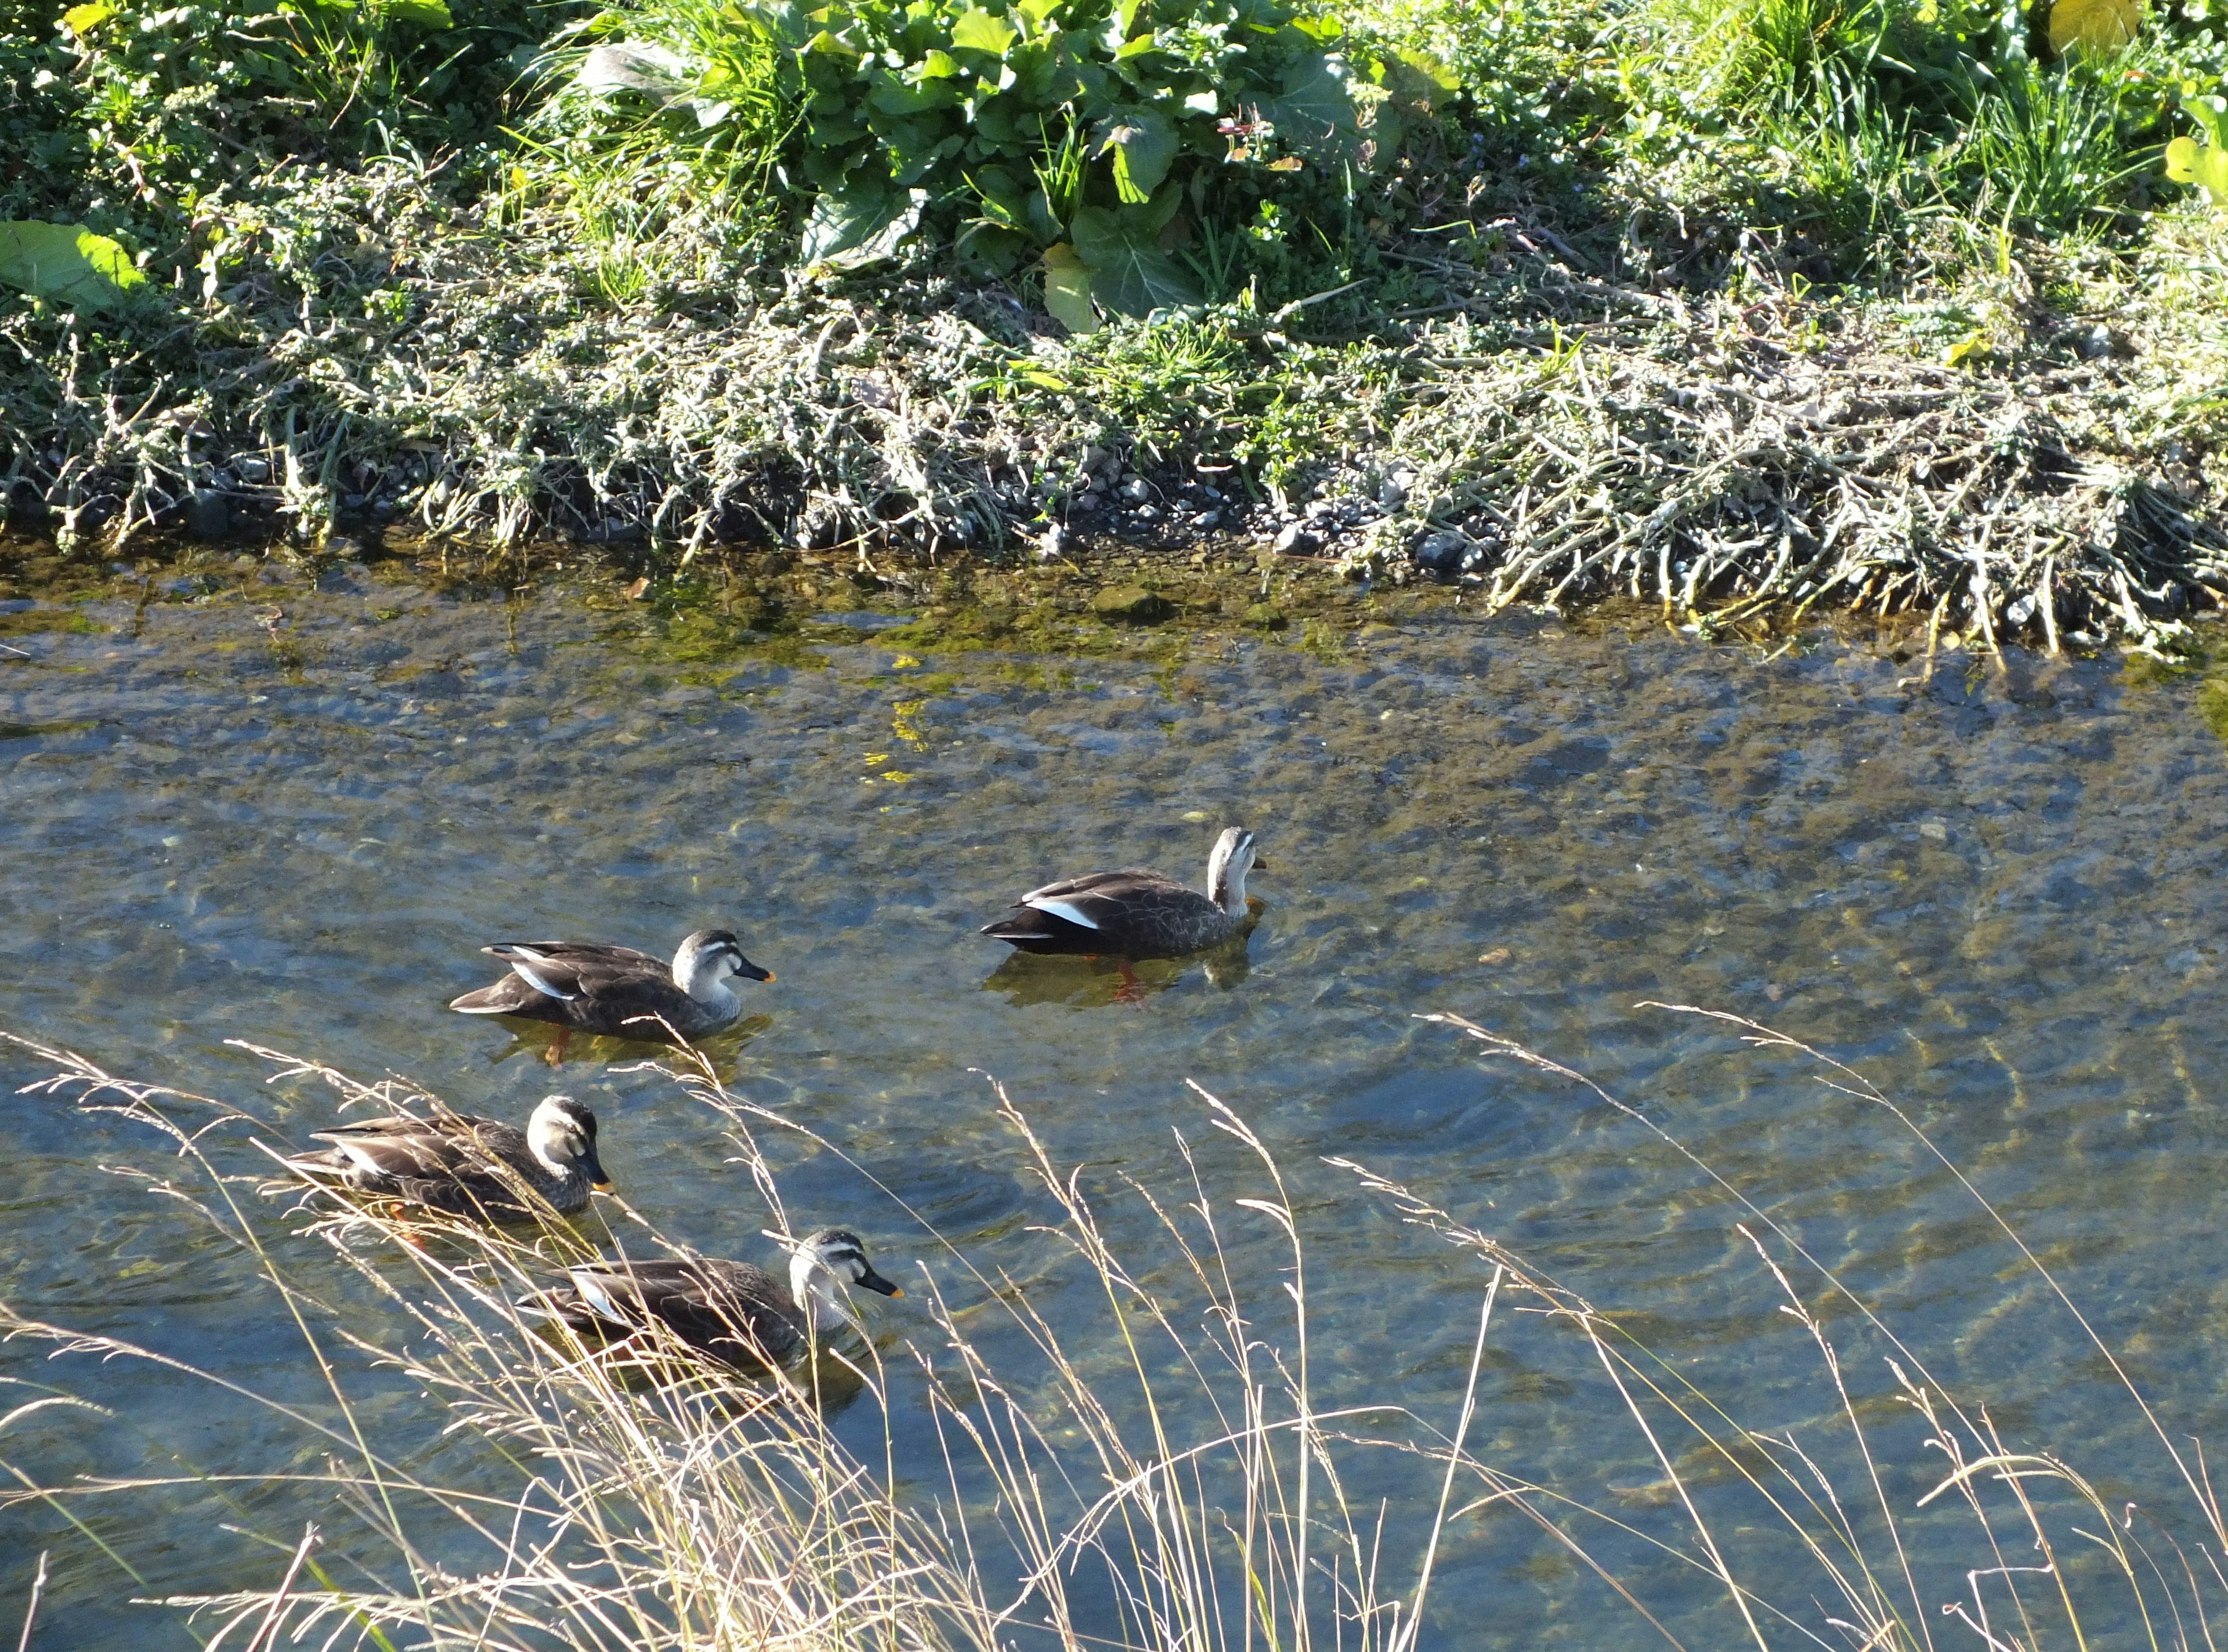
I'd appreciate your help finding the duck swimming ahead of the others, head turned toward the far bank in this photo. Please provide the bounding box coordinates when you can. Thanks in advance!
[982,827,1263,959]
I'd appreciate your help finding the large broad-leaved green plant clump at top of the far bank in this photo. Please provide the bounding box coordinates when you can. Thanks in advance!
[753,0,1446,330]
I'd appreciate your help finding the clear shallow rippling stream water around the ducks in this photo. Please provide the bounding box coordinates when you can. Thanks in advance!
[0,571,2228,1647]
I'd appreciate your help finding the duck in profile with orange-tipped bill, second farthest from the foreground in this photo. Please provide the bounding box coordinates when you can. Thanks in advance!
[448,930,773,1066]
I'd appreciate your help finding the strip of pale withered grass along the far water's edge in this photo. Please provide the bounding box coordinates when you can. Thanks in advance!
[0,161,2228,653]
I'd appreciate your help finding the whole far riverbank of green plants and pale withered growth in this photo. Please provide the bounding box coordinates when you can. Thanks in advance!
[0,0,2228,656]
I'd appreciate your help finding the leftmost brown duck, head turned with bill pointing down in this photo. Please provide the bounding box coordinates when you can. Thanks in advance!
[281,1094,610,1221]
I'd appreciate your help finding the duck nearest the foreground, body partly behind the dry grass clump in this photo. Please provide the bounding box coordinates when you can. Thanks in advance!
[523,1228,905,1371]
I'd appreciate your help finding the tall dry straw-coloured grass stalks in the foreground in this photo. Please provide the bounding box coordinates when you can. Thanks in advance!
[0,1006,2228,1652]
